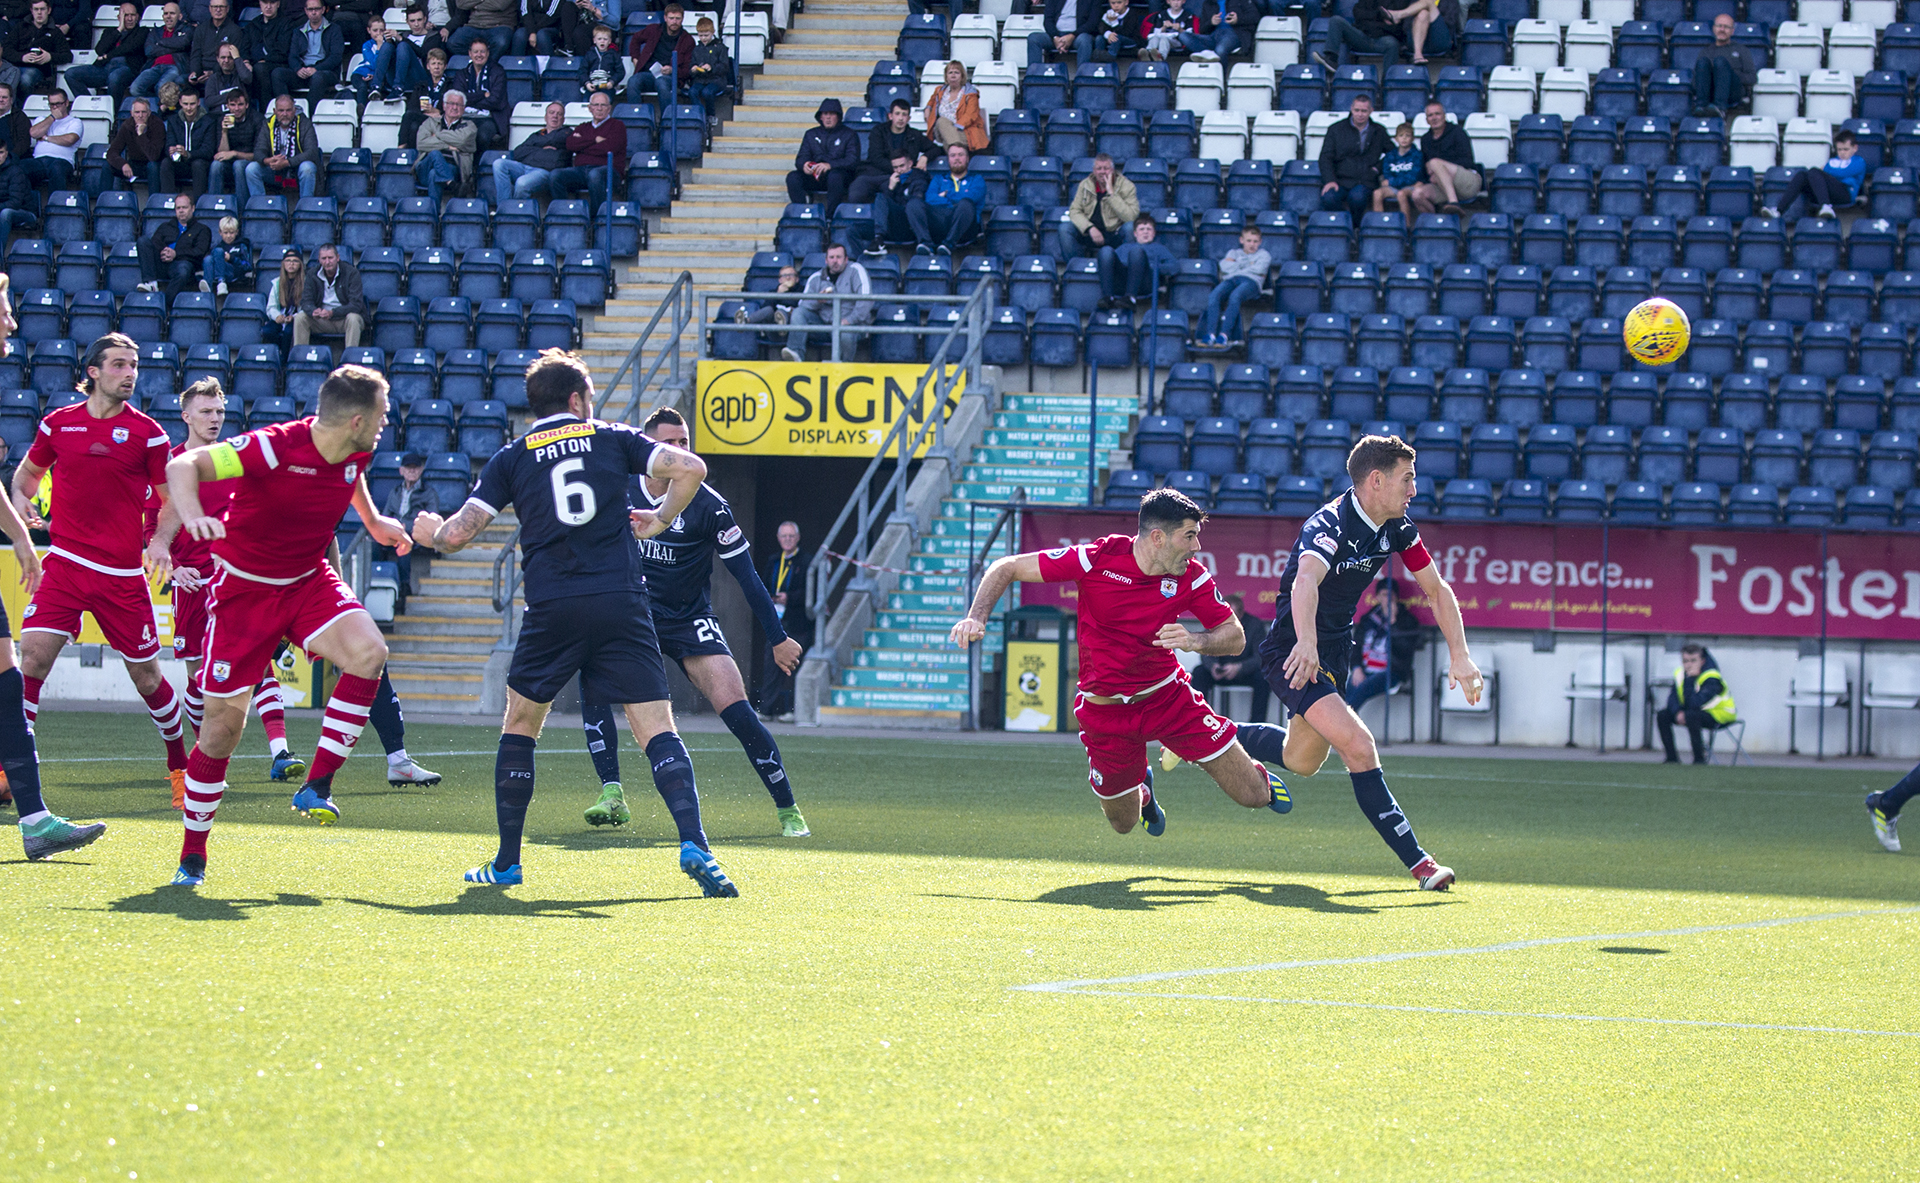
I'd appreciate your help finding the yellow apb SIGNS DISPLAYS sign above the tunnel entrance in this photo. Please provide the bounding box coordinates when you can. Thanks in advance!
[693,361,964,457]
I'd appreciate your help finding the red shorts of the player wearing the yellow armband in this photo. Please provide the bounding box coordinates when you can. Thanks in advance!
[200,563,367,699]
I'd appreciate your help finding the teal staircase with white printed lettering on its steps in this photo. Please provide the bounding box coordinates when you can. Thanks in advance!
[820,384,1139,728]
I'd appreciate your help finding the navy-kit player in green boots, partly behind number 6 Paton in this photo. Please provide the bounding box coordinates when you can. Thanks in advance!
[580,407,810,837]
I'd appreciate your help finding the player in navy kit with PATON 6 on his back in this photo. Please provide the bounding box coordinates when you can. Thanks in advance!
[413,350,739,895]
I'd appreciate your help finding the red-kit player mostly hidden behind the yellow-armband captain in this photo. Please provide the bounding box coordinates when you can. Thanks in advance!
[146,378,307,809]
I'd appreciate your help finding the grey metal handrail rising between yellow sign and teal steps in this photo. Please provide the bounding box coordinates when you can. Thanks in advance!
[806,278,995,620]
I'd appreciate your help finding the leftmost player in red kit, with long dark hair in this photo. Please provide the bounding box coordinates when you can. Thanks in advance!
[13,332,186,795]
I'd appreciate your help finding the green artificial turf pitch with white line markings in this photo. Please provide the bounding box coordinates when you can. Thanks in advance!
[0,712,1920,1181]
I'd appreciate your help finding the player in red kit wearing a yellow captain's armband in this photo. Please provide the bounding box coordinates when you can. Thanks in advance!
[167,365,413,887]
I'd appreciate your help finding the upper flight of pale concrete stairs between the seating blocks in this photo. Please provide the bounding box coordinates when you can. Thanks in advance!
[582,0,900,413]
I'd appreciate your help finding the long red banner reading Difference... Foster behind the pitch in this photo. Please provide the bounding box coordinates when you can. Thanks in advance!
[1020,511,1920,641]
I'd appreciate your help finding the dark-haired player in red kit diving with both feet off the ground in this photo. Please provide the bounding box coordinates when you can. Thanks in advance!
[952,490,1294,837]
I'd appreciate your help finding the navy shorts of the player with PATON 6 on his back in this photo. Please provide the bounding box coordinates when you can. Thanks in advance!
[507,592,668,703]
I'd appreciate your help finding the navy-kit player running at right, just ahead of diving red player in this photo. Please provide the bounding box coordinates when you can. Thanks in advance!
[1240,436,1480,891]
